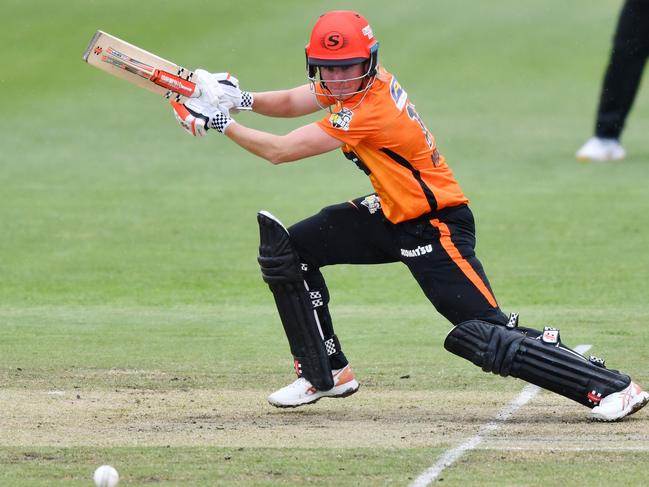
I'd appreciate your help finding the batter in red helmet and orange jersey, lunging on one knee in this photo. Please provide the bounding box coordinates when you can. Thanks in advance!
[172,11,649,421]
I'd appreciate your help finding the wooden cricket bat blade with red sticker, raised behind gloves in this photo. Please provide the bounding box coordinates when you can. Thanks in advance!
[83,30,200,102]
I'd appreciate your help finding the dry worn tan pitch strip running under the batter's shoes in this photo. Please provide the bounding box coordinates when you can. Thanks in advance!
[0,389,649,450]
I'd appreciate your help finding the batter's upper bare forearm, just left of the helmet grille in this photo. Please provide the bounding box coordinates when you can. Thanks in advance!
[252,85,321,117]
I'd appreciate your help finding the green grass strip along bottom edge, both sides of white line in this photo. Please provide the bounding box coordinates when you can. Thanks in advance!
[0,448,646,487]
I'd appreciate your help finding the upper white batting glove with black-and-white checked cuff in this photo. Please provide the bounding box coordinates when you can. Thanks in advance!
[194,69,253,113]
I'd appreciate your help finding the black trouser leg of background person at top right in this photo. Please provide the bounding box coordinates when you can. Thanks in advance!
[595,0,649,139]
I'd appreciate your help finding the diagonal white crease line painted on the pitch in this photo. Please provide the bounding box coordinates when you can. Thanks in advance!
[410,345,592,487]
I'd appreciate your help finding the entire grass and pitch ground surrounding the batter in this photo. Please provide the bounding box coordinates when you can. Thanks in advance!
[0,0,649,487]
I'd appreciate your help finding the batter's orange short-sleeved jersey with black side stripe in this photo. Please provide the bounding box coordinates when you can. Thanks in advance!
[316,67,468,223]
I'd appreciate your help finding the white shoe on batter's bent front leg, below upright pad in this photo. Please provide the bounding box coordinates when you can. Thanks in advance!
[268,365,360,408]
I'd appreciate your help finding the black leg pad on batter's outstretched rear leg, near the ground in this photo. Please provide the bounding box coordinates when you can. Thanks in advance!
[444,320,631,408]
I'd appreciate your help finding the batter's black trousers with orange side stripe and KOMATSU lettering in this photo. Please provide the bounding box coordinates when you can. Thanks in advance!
[288,195,507,368]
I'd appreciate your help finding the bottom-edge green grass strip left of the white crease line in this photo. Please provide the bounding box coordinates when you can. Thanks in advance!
[0,448,442,487]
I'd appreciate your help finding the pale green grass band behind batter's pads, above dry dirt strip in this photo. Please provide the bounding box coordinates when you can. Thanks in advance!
[0,304,649,394]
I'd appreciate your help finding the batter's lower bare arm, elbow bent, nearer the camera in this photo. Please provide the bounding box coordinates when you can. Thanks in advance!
[224,123,343,164]
